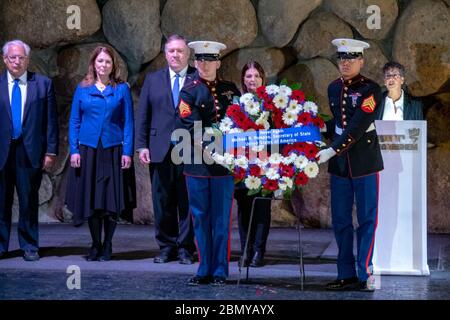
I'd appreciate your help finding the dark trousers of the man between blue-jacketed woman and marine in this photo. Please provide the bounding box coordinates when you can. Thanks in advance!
[150,150,195,253]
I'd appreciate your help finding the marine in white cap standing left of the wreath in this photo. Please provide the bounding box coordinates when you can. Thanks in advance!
[174,41,240,285]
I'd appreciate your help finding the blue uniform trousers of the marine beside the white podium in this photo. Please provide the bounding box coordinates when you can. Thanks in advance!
[331,173,379,281]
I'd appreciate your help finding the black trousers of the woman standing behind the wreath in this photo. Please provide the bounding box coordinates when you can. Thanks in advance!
[234,188,271,255]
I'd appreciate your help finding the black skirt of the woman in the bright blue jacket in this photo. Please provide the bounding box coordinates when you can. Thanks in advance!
[65,142,136,226]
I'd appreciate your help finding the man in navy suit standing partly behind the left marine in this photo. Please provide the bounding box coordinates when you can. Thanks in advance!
[136,35,195,264]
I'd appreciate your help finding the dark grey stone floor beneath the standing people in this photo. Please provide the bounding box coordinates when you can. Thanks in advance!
[0,224,450,300]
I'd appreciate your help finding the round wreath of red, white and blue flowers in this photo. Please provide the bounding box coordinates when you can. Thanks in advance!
[212,80,326,199]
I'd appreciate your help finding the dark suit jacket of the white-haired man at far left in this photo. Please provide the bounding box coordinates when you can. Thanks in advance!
[0,71,59,170]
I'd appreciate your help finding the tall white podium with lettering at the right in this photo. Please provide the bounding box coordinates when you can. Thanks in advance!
[373,120,430,275]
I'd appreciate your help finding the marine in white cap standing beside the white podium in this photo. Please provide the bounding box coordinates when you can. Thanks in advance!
[317,39,383,291]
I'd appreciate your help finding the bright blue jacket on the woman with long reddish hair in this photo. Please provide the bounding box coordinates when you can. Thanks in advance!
[69,83,134,156]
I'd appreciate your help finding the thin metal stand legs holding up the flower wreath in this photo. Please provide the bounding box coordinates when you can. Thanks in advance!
[237,197,305,291]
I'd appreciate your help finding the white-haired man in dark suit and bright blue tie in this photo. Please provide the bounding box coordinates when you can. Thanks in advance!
[0,40,58,261]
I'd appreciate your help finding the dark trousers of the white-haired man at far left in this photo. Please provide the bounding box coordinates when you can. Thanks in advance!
[0,139,42,252]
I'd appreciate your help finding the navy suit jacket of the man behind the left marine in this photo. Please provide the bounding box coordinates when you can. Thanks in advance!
[136,66,196,163]
